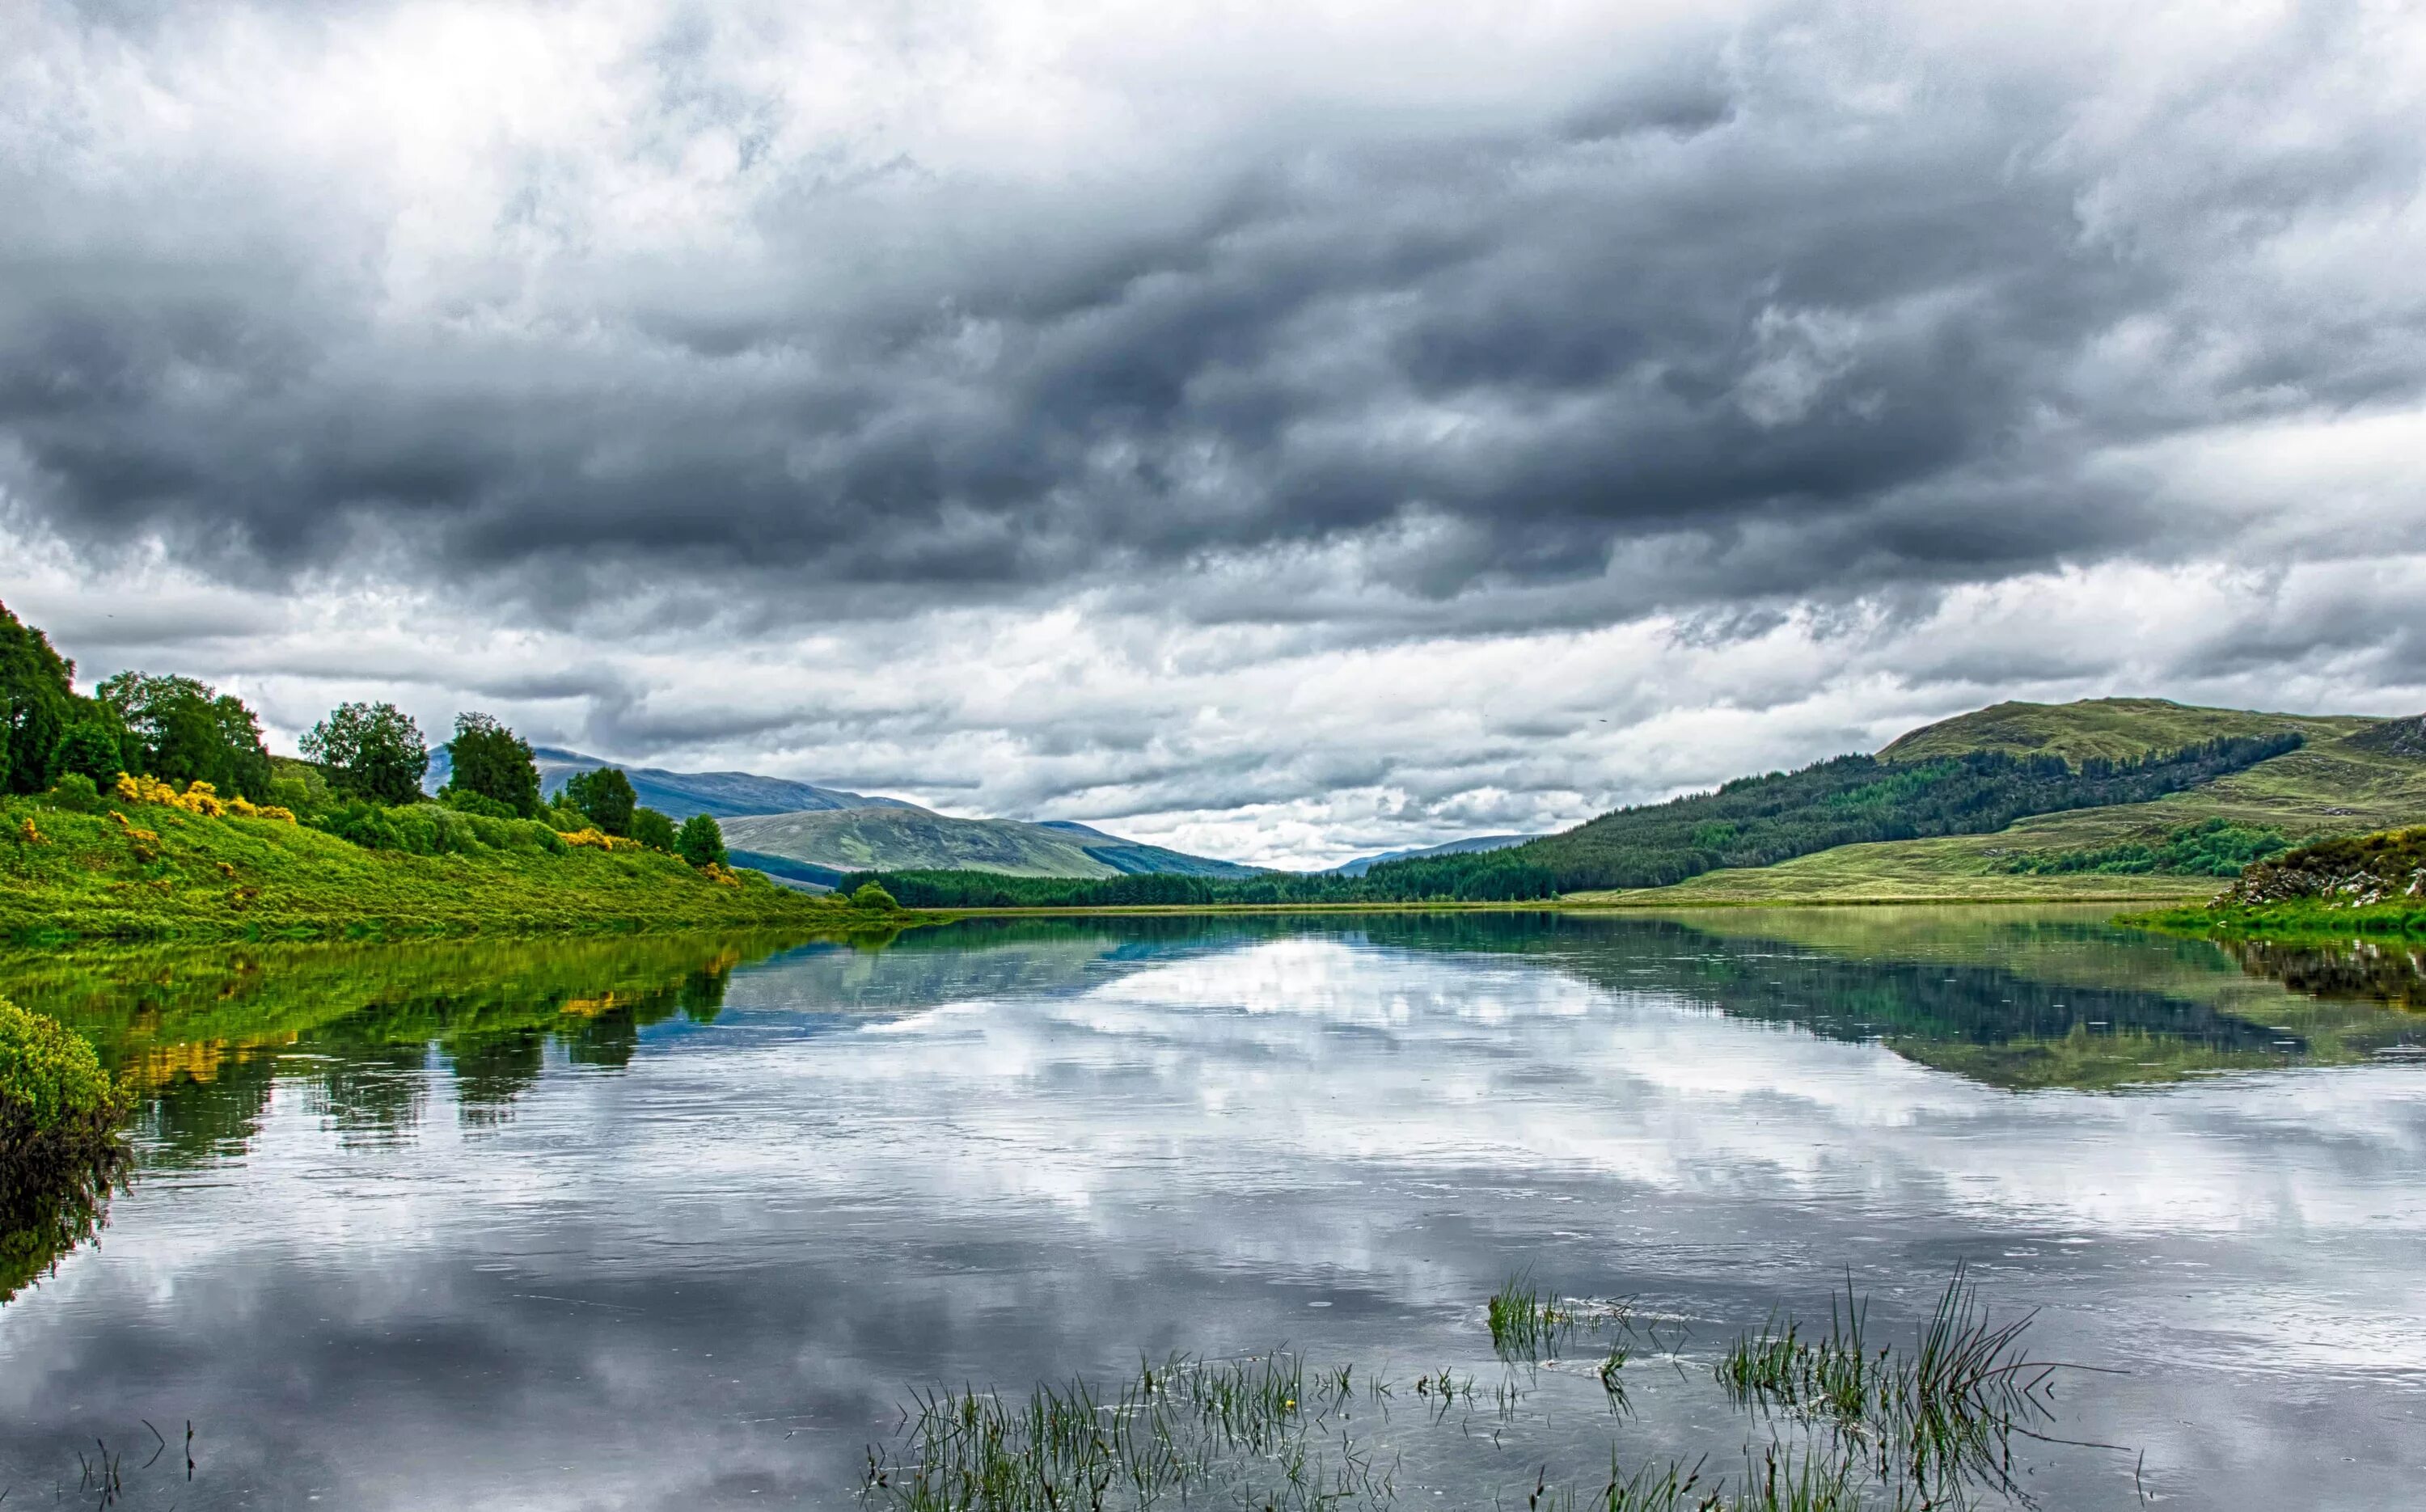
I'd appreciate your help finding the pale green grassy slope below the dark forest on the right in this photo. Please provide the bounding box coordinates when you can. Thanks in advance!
[1567,728,2426,908]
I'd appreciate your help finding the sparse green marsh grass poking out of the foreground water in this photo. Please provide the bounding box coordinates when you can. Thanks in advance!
[861,1267,2106,1512]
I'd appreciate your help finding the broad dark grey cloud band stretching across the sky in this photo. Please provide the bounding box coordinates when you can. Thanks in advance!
[0,7,2426,621]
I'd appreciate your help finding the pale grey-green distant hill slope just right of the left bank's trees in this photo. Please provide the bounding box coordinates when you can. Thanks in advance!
[723,806,1254,886]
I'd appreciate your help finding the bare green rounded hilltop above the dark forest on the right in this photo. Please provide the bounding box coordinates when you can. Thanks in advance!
[1878,699,2375,770]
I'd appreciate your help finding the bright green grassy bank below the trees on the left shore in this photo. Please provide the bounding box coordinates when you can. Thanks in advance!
[0,799,893,947]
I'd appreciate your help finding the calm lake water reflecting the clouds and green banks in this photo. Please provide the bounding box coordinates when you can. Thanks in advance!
[0,910,2426,1510]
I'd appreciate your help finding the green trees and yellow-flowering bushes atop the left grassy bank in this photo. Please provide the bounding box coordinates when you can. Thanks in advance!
[0,604,725,867]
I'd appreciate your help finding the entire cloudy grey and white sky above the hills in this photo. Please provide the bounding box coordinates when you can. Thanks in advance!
[0,0,2426,867]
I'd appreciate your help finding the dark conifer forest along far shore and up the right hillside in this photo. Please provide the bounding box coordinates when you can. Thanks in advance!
[842,733,2302,908]
